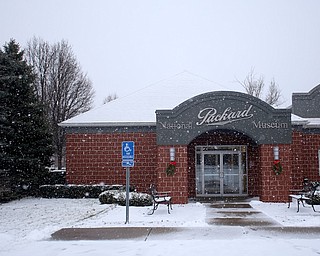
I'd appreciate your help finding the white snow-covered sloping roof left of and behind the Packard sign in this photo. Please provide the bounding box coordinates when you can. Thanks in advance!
[60,71,240,127]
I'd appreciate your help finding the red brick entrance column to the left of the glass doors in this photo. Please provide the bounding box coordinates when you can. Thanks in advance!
[157,145,188,204]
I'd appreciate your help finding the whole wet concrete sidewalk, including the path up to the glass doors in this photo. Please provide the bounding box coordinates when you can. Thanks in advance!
[52,202,320,241]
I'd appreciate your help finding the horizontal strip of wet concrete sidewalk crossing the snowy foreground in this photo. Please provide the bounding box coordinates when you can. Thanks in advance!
[52,226,320,241]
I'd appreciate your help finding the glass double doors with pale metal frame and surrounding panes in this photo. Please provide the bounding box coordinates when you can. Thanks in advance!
[196,145,248,196]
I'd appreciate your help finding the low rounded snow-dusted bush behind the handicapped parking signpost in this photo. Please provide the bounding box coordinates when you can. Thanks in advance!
[99,190,152,206]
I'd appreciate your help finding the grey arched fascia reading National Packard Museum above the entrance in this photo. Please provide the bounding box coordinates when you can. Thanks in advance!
[156,91,291,145]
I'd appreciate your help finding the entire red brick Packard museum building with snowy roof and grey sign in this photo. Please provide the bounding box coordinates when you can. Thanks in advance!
[60,73,320,203]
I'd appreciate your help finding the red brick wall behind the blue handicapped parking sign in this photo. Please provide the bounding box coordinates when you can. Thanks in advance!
[66,132,157,192]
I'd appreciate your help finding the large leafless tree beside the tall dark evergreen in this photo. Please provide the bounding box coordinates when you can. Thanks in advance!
[26,38,94,169]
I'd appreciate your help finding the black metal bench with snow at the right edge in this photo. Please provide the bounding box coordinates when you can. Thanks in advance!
[288,182,320,212]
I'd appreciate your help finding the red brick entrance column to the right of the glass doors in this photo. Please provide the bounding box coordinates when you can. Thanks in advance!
[259,144,291,202]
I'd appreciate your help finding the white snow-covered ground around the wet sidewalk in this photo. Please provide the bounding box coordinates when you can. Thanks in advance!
[0,198,320,256]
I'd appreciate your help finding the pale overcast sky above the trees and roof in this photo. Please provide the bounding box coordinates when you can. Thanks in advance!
[0,0,320,106]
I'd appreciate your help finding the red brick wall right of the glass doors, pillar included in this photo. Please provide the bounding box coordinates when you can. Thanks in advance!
[259,131,320,202]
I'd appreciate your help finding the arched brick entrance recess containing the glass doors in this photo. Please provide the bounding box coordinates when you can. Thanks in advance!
[188,130,258,197]
